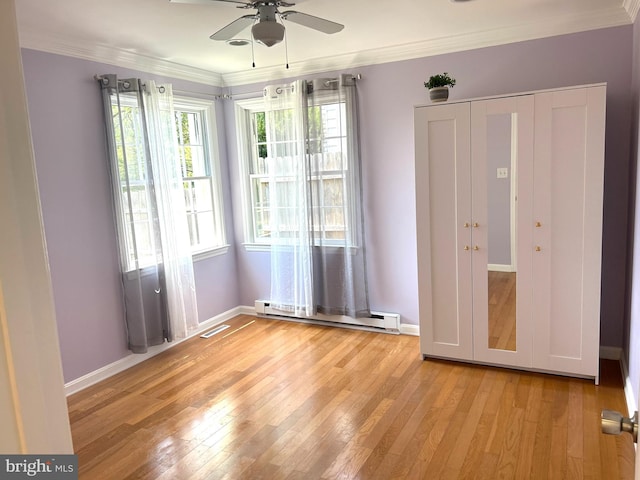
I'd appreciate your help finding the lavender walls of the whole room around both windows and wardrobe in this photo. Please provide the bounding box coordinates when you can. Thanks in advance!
[18,26,637,382]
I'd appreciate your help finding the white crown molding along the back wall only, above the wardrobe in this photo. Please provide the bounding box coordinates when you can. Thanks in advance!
[222,6,640,87]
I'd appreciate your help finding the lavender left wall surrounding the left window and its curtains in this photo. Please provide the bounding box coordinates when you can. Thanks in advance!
[22,50,238,382]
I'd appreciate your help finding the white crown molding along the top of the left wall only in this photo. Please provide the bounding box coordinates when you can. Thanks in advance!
[20,31,223,87]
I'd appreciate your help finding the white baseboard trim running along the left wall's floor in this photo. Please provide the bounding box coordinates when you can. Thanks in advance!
[64,307,248,396]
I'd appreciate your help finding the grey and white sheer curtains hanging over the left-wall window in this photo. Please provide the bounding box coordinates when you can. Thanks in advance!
[97,75,198,353]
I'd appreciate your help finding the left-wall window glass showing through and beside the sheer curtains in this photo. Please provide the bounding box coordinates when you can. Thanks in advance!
[112,95,226,270]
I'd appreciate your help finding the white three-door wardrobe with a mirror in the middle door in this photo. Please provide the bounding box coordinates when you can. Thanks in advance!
[415,85,606,382]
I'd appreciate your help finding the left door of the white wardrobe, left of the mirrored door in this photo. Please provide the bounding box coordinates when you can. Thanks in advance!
[415,103,473,360]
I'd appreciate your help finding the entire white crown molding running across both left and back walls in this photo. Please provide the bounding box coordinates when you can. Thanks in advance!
[20,4,640,87]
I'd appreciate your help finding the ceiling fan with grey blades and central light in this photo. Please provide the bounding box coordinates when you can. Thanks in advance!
[169,0,344,47]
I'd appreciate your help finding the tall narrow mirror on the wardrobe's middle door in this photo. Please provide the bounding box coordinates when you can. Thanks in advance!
[487,114,516,351]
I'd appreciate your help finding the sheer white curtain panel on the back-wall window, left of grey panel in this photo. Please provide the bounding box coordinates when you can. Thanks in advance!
[264,80,315,316]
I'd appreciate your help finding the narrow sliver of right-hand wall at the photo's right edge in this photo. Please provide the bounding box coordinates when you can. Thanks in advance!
[624,15,640,413]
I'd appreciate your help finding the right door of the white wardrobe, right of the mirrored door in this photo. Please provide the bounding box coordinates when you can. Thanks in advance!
[533,86,605,380]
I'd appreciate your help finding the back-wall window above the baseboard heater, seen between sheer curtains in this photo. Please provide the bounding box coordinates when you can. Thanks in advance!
[236,97,353,245]
